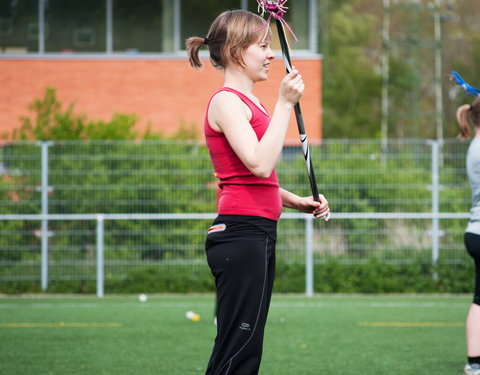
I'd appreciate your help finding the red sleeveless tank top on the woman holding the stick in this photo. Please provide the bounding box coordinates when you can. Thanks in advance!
[204,87,282,220]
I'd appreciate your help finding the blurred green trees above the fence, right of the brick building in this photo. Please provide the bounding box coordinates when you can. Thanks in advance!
[319,0,480,138]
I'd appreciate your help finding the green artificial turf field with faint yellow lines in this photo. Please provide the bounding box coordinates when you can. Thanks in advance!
[0,295,470,375]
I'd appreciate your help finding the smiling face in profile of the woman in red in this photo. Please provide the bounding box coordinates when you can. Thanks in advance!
[242,38,275,82]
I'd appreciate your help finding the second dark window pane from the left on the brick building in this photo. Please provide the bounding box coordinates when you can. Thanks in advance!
[45,0,106,53]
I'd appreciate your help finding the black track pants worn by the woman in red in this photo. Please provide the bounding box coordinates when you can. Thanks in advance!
[206,215,276,375]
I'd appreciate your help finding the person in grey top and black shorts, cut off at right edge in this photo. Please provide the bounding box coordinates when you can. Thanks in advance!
[457,96,480,375]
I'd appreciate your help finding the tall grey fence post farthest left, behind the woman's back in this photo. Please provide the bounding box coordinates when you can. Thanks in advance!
[39,142,52,291]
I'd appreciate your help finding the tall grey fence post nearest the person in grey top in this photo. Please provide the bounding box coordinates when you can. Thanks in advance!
[430,140,441,278]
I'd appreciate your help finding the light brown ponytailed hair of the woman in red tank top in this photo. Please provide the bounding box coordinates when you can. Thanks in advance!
[185,10,271,70]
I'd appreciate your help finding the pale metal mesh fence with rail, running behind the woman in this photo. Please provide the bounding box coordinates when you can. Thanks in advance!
[0,140,471,295]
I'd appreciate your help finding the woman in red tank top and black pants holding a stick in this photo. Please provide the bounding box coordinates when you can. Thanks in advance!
[186,10,330,375]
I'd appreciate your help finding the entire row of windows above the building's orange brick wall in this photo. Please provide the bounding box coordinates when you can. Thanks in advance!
[0,0,316,57]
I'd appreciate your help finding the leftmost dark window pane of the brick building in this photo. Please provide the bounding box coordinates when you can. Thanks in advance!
[0,0,38,54]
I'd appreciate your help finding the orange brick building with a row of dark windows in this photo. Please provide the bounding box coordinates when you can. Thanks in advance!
[0,0,322,143]
